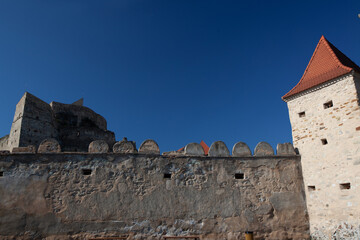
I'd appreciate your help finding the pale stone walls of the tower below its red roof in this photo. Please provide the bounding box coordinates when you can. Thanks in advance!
[288,76,360,239]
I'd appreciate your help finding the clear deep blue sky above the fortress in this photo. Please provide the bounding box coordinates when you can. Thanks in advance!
[0,0,360,152]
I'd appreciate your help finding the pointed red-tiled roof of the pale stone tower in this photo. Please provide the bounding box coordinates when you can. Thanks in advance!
[282,36,360,100]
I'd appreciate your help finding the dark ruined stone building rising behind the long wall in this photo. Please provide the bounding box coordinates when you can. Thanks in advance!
[8,93,115,152]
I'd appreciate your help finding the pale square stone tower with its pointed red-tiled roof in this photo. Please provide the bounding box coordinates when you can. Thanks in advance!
[282,36,360,239]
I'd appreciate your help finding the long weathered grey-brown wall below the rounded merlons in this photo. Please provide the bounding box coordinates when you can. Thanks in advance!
[0,153,309,240]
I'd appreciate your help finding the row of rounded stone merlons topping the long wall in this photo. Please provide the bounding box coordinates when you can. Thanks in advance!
[0,138,297,158]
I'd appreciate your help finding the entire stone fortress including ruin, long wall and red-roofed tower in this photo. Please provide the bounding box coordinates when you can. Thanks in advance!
[0,37,360,240]
